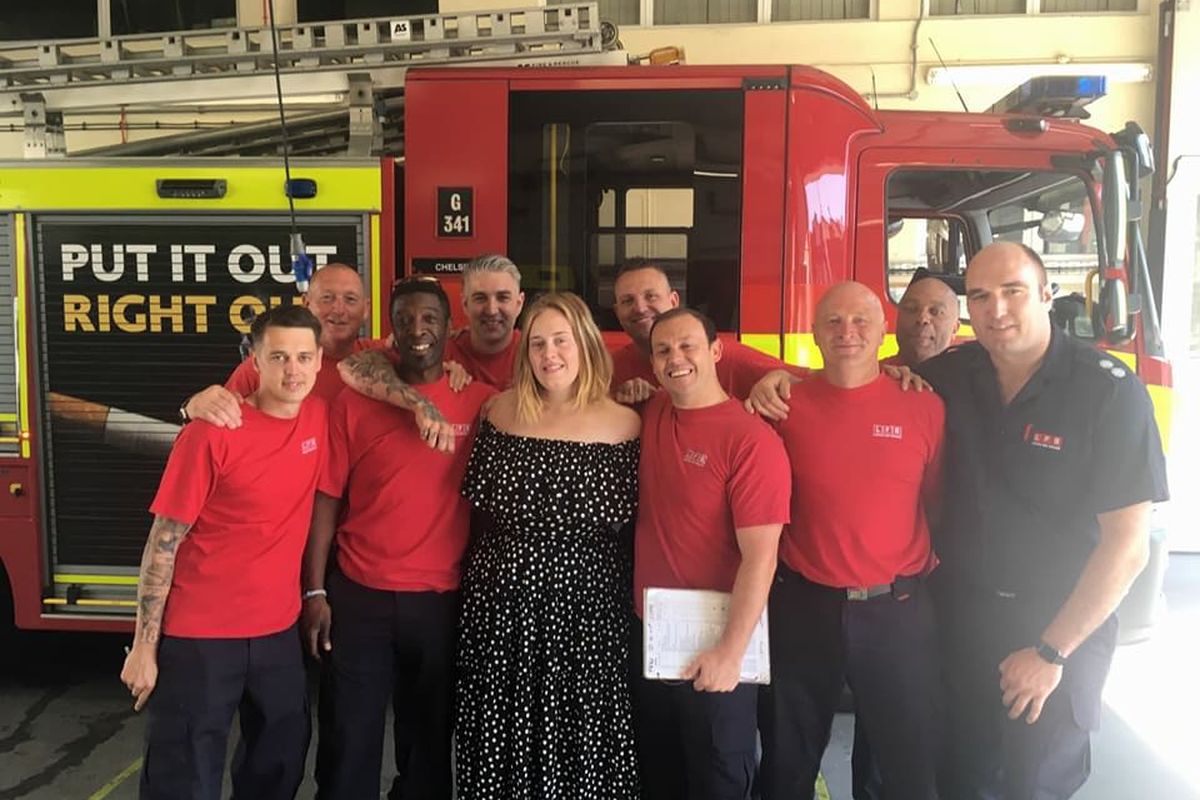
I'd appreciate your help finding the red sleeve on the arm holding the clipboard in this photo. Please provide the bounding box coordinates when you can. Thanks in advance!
[727,420,792,529]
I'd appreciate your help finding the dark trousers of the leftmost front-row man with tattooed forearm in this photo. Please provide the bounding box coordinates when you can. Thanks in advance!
[139,626,310,800]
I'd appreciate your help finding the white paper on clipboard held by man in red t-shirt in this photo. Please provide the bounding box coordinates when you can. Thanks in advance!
[642,589,770,684]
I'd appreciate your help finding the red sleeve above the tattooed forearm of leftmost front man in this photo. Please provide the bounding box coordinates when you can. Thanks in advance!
[150,422,224,525]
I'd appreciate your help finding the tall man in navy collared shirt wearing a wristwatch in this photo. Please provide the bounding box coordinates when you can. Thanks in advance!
[918,242,1166,800]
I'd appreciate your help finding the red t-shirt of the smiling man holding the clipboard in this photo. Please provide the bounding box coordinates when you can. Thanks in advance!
[634,392,791,615]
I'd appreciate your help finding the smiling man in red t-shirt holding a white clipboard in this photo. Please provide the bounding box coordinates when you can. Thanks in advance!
[634,308,790,800]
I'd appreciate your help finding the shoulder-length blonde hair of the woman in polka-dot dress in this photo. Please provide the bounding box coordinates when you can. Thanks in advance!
[512,291,612,422]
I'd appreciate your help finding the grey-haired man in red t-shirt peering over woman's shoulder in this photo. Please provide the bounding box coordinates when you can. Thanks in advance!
[445,253,524,389]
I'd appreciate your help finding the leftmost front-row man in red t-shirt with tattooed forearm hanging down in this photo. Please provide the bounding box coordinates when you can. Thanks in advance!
[121,306,326,800]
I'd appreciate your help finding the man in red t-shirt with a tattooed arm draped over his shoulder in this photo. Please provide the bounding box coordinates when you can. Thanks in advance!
[302,279,496,800]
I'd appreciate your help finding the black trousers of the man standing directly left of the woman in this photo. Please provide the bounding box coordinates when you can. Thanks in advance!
[317,571,458,800]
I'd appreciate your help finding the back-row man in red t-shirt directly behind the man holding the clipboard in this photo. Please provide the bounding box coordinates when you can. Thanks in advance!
[612,258,808,405]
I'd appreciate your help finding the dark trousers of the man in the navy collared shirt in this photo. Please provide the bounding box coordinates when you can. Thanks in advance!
[938,582,1117,800]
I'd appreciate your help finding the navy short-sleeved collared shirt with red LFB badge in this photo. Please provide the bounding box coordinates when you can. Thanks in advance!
[917,327,1168,626]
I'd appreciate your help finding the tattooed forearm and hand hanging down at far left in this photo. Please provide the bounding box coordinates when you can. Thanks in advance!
[121,516,191,711]
